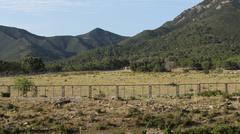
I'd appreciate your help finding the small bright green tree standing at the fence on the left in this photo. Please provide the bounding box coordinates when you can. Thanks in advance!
[15,78,34,96]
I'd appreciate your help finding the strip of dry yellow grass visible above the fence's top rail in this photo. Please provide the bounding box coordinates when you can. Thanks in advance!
[0,71,240,85]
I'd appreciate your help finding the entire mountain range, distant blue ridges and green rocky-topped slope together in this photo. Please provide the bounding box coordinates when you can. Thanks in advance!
[0,0,240,70]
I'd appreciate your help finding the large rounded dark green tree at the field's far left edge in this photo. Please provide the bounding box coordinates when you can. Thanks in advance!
[21,55,45,73]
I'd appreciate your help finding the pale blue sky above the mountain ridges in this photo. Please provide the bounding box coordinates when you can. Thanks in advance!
[0,0,202,36]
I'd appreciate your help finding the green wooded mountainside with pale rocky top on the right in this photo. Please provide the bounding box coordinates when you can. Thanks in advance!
[66,0,240,70]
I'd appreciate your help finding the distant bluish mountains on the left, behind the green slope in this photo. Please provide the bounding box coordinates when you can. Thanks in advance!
[0,26,128,61]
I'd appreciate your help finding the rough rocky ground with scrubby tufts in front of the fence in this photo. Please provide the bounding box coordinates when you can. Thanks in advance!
[0,96,240,134]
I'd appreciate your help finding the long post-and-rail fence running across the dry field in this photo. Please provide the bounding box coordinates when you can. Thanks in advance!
[0,82,240,98]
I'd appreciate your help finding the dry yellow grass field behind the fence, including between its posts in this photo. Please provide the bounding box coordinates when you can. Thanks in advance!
[0,71,240,98]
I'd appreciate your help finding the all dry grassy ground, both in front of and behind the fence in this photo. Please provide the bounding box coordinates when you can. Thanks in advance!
[0,71,240,134]
